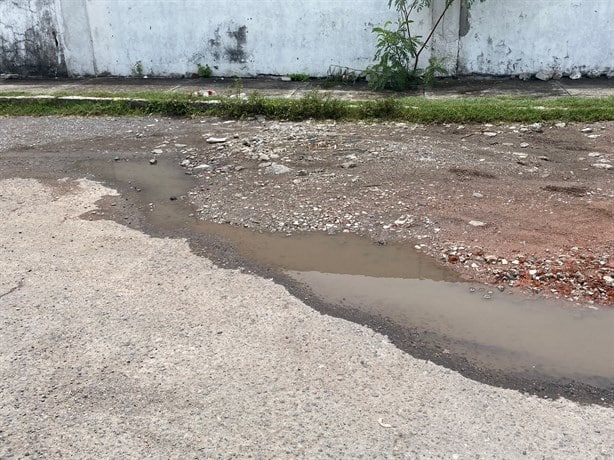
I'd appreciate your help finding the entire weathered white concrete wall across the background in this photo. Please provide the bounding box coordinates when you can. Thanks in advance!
[0,0,614,76]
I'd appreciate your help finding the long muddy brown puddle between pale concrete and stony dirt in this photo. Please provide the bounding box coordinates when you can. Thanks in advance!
[78,160,614,390]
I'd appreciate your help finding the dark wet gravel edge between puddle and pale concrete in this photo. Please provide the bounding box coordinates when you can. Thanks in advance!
[22,158,614,407]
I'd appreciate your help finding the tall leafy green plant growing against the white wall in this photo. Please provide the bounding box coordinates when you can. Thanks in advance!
[366,0,485,91]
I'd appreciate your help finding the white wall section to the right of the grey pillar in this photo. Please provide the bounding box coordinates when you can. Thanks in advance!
[458,0,614,75]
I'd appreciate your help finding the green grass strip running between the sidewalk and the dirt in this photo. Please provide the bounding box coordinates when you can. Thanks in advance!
[0,92,614,123]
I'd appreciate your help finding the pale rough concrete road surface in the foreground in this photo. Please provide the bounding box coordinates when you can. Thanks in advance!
[0,179,614,459]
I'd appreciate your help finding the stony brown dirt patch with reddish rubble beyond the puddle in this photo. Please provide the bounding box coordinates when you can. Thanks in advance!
[184,120,614,305]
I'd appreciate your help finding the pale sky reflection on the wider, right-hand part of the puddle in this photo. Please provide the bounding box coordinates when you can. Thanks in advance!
[287,271,614,388]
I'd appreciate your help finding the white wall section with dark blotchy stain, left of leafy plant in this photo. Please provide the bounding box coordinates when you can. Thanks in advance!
[60,0,430,76]
